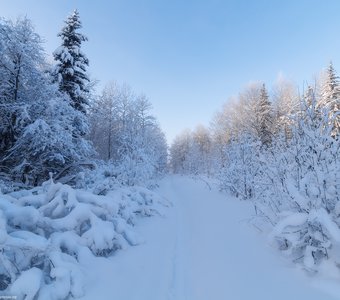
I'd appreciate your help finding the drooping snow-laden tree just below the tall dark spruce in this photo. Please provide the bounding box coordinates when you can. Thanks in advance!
[3,95,93,185]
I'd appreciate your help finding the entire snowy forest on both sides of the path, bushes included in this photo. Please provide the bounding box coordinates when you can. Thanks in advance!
[0,10,340,300]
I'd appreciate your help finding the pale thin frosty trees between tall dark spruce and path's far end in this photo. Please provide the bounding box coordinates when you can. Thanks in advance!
[89,82,167,184]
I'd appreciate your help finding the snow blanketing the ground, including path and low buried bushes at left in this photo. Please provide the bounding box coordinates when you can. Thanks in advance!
[0,175,340,300]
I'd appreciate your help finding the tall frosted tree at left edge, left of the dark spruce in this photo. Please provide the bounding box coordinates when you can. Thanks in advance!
[0,18,45,159]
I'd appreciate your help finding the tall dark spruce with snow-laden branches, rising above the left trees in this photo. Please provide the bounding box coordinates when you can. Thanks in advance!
[53,10,90,114]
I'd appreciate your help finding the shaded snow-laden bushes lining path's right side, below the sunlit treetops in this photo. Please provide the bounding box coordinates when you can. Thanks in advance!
[228,97,340,271]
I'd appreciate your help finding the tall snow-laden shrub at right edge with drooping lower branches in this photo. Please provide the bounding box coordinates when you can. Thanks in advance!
[256,99,340,270]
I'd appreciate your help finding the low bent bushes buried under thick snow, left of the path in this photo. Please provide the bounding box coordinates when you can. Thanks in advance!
[0,180,167,299]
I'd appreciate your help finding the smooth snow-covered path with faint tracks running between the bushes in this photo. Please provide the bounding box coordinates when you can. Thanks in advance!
[79,176,340,300]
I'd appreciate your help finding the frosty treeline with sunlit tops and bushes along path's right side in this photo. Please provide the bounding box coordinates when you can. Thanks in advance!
[170,64,340,271]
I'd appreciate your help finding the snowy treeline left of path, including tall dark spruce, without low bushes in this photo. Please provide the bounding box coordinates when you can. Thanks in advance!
[0,11,167,190]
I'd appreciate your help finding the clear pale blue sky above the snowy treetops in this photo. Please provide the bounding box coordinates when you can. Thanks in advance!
[0,0,340,140]
